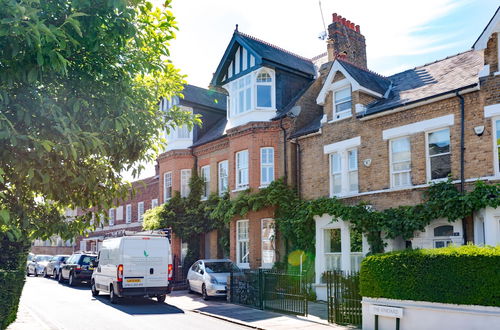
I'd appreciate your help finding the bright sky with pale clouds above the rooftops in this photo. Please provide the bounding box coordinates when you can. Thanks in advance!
[131,0,499,180]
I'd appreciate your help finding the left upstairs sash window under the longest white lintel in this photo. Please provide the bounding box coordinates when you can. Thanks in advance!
[389,137,411,188]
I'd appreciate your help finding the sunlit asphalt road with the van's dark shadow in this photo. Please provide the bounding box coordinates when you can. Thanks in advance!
[16,277,249,330]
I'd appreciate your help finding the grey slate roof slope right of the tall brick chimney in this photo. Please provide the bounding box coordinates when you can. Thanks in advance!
[364,50,483,116]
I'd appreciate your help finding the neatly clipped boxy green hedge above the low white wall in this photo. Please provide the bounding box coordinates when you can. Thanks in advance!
[360,245,500,307]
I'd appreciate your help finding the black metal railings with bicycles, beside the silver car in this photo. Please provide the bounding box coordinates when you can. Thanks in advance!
[229,269,307,316]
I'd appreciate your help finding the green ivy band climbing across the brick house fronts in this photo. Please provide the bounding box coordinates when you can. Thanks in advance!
[145,177,500,260]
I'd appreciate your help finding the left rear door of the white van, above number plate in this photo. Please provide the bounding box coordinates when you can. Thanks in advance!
[121,237,147,288]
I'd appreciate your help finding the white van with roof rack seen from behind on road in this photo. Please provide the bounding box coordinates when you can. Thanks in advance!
[91,235,173,304]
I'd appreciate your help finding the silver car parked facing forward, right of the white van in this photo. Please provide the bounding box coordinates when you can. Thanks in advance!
[187,259,240,300]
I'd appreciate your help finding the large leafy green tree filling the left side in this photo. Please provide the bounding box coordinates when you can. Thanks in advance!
[0,0,199,328]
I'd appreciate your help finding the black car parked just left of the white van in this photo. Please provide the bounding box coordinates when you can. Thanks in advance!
[58,253,97,286]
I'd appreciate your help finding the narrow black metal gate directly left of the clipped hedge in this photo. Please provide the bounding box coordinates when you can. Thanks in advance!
[326,271,362,326]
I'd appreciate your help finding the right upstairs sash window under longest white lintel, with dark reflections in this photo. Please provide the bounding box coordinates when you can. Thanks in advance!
[427,128,451,180]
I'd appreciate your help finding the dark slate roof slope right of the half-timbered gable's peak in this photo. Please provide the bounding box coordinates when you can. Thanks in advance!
[235,31,316,76]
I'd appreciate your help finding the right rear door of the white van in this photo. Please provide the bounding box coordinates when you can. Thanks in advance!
[144,237,170,287]
